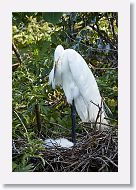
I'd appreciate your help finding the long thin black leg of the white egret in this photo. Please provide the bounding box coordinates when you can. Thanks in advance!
[71,100,76,144]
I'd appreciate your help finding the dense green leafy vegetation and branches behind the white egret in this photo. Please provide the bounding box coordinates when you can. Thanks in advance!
[12,12,118,171]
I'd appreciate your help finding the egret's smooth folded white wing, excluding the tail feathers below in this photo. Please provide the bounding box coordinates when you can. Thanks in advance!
[65,49,101,105]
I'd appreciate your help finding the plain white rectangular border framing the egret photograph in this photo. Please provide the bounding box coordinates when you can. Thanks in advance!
[0,0,130,184]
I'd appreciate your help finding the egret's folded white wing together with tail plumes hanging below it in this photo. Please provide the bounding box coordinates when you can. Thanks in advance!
[65,49,104,121]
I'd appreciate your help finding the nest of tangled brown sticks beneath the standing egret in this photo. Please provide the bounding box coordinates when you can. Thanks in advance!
[32,127,118,172]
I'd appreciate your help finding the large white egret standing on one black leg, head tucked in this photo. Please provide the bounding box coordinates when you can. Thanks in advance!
[49,45,107,143]
